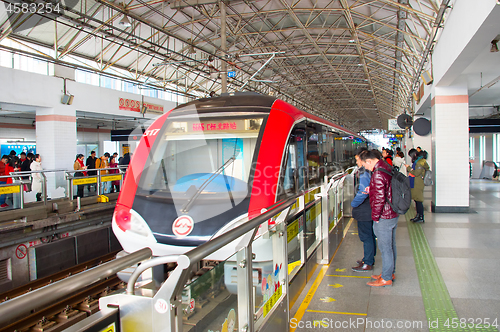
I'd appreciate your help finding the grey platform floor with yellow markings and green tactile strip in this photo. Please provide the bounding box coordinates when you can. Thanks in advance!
[290,180,500,331]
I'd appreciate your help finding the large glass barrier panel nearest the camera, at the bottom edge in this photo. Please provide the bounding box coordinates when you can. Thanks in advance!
[182,254,238,332]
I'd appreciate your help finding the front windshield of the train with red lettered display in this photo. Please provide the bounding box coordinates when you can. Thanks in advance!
[137,106,265,219]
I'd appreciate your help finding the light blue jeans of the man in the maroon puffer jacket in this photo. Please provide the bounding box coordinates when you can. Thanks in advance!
[373,216,399,280]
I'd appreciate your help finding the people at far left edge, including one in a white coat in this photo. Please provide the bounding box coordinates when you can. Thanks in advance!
[0,150,43,209]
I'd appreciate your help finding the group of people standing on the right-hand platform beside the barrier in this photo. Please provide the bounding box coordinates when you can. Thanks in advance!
[351,147,429,287]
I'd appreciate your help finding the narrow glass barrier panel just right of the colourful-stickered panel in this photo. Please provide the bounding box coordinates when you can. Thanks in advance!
[286,214,305,280]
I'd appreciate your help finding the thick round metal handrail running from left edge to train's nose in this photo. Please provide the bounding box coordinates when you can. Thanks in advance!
[0,248,152,326]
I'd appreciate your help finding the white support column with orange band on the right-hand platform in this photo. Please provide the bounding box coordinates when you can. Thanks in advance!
[431,84,469,213]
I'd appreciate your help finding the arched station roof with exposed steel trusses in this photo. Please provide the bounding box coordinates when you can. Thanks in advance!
[0,0,448,131]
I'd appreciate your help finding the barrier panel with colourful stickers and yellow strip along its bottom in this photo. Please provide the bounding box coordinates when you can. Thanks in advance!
[252,222,288,329]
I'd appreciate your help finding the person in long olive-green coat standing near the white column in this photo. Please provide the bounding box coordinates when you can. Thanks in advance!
[406,149,429,223]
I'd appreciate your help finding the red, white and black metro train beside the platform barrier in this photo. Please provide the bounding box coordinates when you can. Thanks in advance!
[112,93,366,260]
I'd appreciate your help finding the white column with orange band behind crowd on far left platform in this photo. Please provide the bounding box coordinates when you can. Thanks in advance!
[36,105,77,198]
